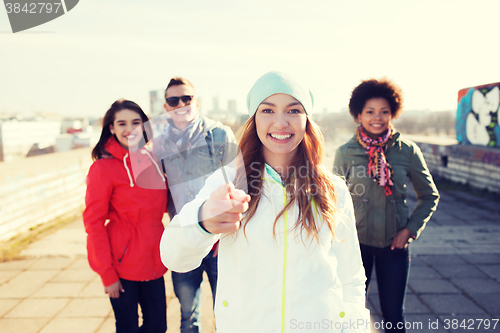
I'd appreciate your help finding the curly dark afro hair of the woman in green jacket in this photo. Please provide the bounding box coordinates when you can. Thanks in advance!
[349,77,403,121]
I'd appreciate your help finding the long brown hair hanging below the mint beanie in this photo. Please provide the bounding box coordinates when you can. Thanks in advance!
[236,114,337,242]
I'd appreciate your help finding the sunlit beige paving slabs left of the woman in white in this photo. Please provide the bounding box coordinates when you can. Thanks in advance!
[0,220,215,333]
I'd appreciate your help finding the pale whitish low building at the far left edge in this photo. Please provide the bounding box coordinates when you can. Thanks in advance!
[0,120,61,161]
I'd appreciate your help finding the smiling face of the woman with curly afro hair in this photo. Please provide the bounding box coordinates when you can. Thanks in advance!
[358,98,392,139]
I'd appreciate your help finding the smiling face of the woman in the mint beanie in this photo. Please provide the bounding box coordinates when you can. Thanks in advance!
[255,94,307,169]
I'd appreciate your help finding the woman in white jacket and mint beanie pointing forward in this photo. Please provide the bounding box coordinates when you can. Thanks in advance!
[160,72,369,333]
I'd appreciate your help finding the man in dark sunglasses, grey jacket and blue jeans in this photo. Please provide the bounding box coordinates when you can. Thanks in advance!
[153,77,234,333]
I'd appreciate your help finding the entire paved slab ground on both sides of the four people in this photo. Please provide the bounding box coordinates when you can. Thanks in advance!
[0,183,500,333]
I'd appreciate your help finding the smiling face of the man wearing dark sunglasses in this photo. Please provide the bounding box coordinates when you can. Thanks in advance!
[164,84,199,130]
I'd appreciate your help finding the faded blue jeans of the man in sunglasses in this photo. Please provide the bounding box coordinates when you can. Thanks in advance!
[172,251,217,333]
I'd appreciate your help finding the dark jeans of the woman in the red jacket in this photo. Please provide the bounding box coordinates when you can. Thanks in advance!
[110,276,167,333]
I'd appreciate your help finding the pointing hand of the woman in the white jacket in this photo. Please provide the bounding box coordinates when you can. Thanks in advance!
[200,183,250,234]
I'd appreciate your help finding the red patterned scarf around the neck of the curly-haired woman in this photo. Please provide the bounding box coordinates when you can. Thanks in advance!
[356,125,394,196]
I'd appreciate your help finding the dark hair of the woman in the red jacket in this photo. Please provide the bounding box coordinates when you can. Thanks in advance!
[92,99,152,161]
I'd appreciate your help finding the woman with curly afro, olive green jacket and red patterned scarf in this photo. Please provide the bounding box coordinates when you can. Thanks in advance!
[334,78,439,332]
